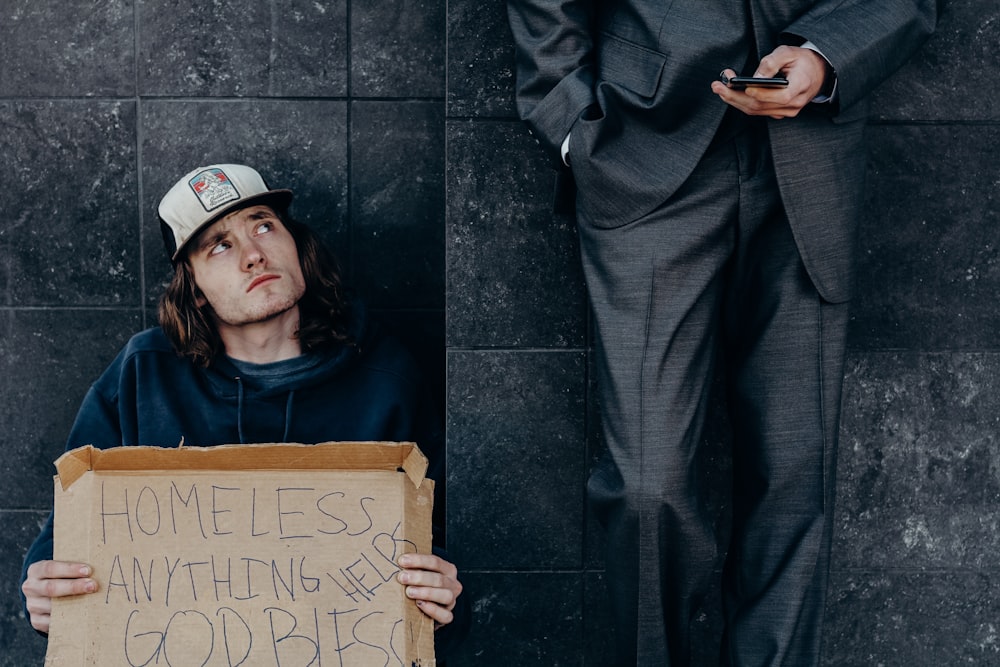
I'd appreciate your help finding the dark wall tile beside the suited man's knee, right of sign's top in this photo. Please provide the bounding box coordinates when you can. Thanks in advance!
[447,350,585,570]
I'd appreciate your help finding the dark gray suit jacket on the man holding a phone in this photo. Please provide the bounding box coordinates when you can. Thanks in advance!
[508,0,936,302]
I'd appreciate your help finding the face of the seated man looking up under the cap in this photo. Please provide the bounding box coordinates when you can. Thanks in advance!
[188,206,305,331]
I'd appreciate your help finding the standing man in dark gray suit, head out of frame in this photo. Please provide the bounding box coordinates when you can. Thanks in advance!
[508,0,936,667]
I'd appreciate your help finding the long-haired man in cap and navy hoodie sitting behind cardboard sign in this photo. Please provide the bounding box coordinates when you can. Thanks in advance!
[21,164,469,654]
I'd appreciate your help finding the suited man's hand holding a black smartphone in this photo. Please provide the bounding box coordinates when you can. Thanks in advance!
[712,46,828,118]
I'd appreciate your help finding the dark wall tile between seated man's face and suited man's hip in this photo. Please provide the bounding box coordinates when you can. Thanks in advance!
[447,121,586,349]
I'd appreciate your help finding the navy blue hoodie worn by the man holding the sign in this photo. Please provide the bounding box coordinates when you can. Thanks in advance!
[21,304,469,657]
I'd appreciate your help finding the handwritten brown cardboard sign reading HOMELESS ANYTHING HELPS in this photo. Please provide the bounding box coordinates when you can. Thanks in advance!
[45,443,435,667]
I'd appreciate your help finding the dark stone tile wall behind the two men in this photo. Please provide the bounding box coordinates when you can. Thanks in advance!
[0,0,1000,667]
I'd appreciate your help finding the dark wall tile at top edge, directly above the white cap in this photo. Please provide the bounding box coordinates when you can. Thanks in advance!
[136,0,349,98]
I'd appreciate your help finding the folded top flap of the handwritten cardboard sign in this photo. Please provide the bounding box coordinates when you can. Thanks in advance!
[55,441,427,491]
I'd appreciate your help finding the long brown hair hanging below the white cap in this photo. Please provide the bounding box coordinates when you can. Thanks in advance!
[158,211,354,366]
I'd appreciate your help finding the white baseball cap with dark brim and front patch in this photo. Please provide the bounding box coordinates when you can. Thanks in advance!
[157,164,292,262]
